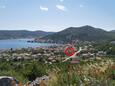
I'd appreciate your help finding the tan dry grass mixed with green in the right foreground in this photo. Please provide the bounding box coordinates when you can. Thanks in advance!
[48,58,115,86]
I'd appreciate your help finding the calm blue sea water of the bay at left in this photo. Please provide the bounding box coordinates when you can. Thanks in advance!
[0,39,54,49]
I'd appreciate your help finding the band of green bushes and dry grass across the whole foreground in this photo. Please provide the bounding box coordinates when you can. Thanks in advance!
[0,58,115,86]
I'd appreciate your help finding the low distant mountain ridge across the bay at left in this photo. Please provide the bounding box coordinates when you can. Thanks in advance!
[0,30,54,39]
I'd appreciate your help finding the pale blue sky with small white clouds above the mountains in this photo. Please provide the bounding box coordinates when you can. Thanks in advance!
[0,0,115,32]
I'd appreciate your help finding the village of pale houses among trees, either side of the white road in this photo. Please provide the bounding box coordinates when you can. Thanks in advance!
[0,44,106,64]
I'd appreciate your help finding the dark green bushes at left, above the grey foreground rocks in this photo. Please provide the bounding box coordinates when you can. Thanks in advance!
[0,61,48,83]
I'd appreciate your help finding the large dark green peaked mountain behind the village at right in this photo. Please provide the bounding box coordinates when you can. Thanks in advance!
[43,25,115,43]
